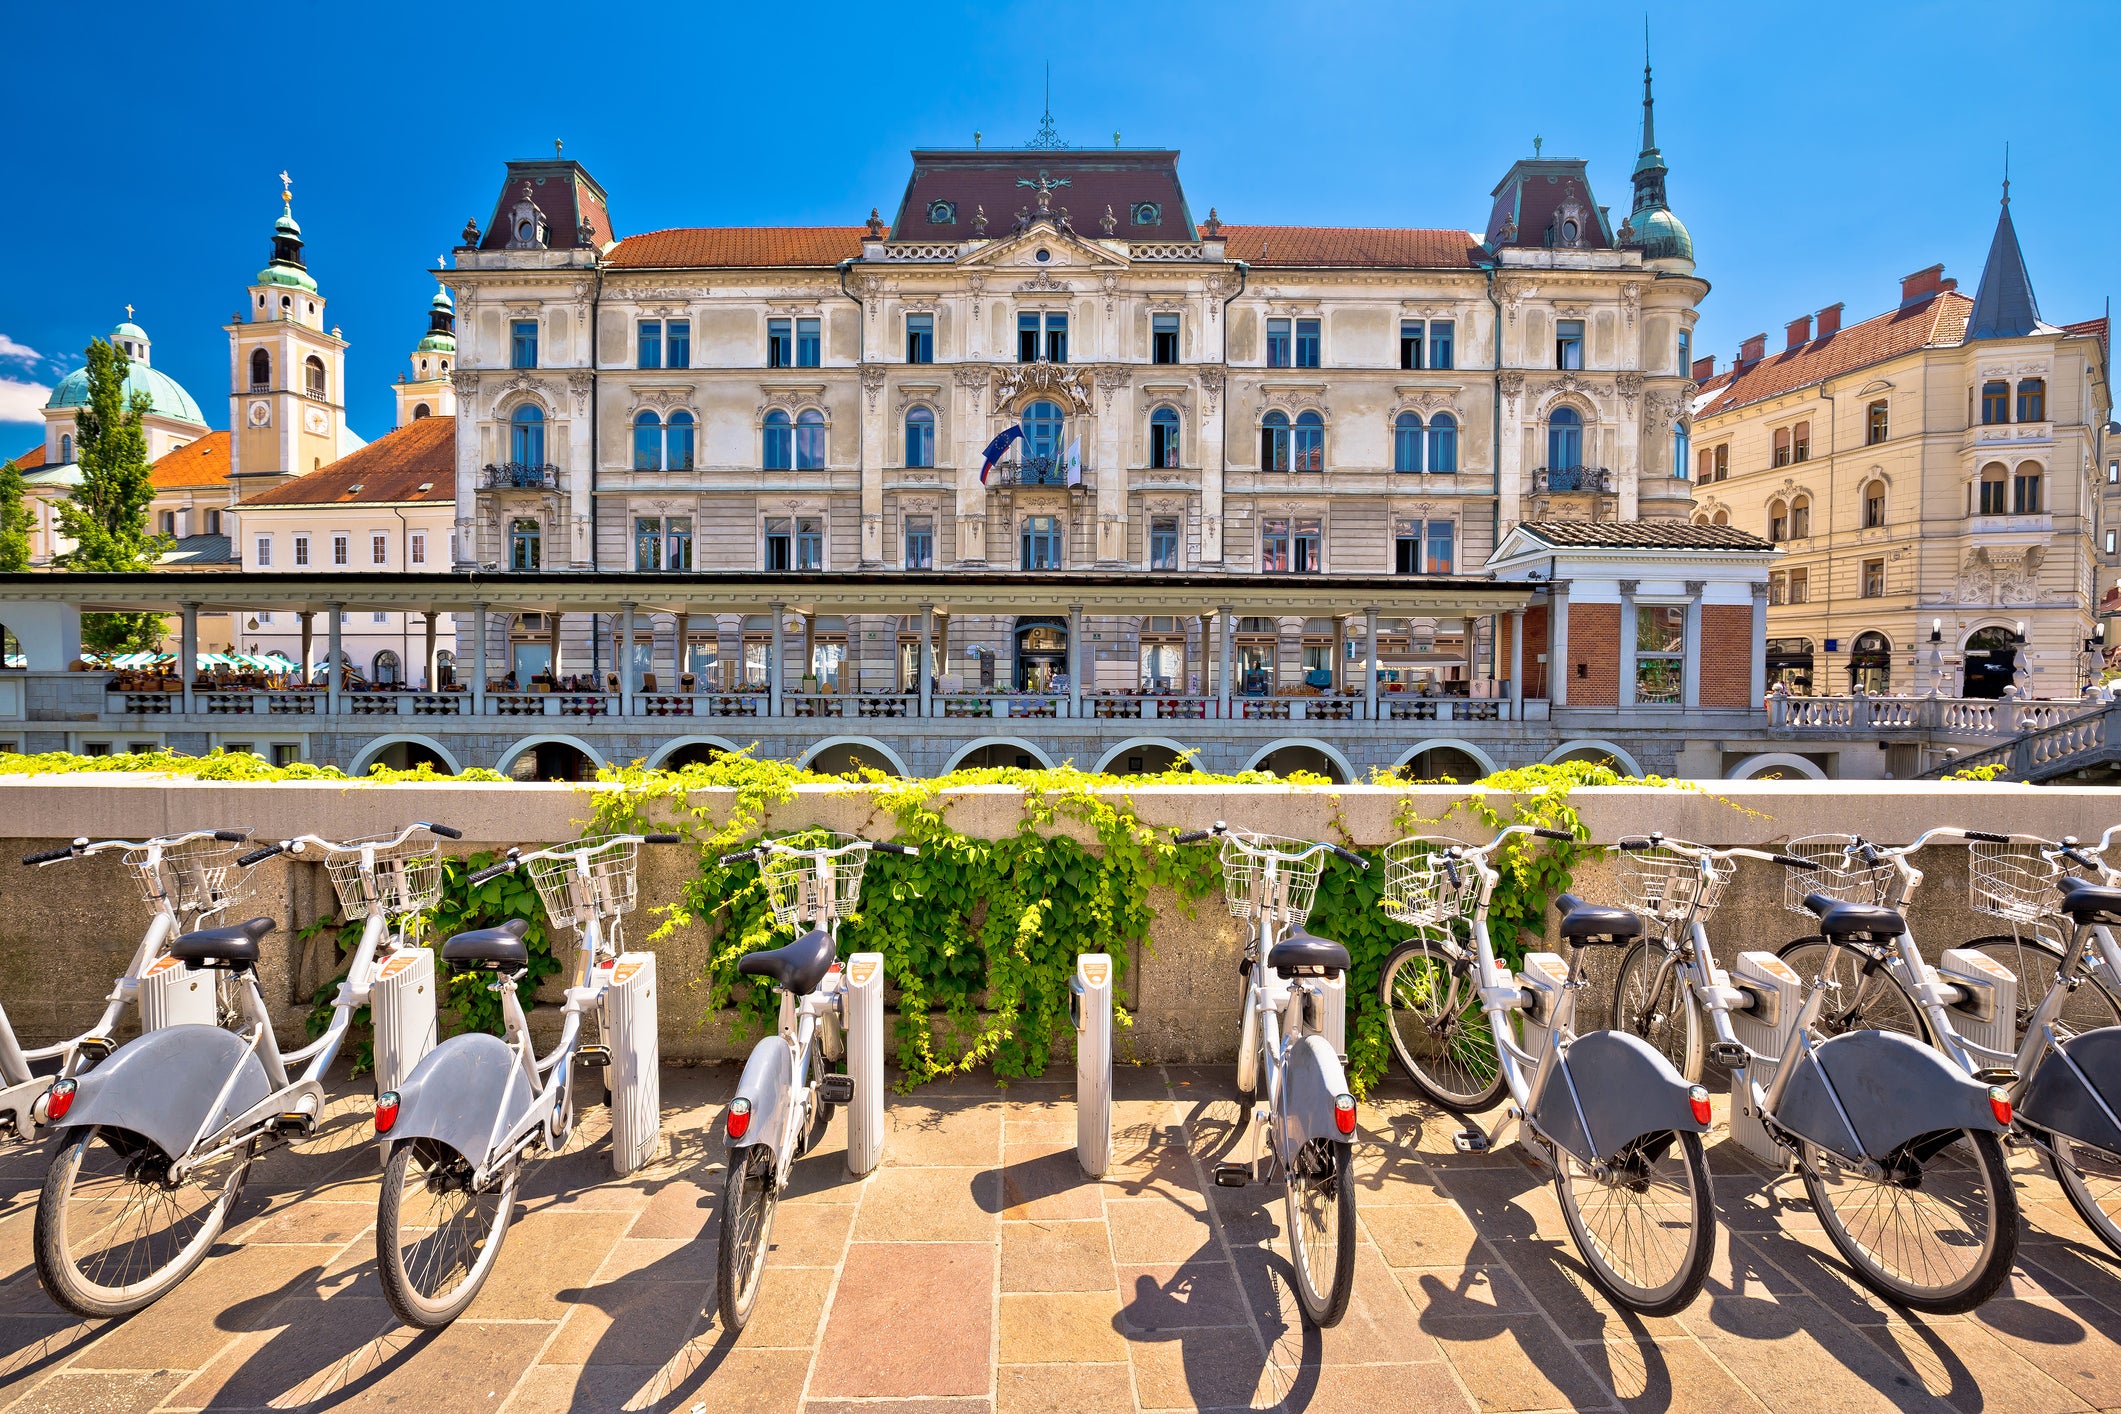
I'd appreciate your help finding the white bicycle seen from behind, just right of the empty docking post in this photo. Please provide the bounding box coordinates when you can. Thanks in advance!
[1177,820,1370,1327]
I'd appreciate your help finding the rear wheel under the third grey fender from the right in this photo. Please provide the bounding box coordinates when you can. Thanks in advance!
[1555,1130,1716,1316]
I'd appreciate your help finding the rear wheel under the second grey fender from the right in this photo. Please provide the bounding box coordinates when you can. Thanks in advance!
[1801,1130,2017,1316]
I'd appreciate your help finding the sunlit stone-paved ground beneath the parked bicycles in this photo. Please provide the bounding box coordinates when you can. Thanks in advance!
[0,1066,2121,1414]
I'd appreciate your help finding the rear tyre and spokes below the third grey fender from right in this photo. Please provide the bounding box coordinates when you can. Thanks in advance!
[1555,1130,1716,1316]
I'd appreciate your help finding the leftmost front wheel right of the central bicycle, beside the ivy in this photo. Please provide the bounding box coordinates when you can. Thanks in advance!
[1377,937,1504,1113]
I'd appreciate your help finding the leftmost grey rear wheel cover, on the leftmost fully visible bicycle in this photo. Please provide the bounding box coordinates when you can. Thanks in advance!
[66,1026,271,1157]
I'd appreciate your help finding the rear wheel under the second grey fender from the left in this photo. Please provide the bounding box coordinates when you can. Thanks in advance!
[375,1138,522,1329]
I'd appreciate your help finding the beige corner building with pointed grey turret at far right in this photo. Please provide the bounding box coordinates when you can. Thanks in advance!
[1693,191,2121,697]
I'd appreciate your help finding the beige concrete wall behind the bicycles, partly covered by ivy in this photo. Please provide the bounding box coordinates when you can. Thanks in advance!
[0,776,2121,1060]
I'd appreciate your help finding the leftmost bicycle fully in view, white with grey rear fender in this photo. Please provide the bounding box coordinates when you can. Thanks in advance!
[34,820,460,1316]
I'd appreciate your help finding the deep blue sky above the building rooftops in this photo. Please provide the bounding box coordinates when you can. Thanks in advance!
[0,0,2121,456]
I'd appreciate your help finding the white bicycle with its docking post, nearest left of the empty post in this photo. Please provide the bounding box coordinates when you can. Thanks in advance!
[715,831,921,1331]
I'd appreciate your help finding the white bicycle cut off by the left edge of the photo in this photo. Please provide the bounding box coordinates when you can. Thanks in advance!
[0,829,250,1143]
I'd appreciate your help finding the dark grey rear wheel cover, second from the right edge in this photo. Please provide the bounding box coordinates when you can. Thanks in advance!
[1775,1030,2004,1160]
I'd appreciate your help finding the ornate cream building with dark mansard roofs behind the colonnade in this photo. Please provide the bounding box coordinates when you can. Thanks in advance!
[437,86,1707,693]
